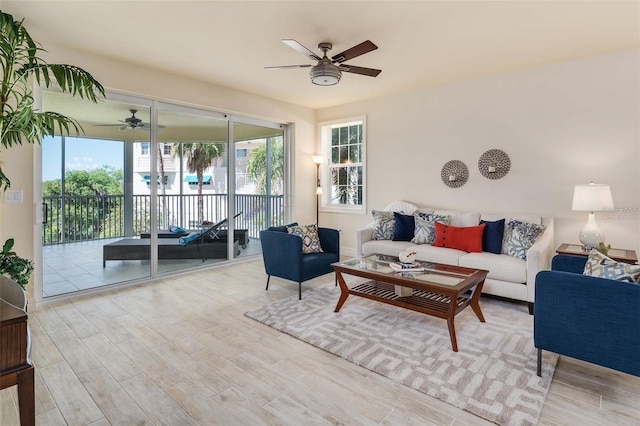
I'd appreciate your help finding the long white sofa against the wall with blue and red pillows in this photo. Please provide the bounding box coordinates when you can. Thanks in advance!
[356,202,554,313]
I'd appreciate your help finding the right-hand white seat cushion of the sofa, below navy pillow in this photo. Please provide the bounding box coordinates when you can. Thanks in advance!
[460,252,527,283]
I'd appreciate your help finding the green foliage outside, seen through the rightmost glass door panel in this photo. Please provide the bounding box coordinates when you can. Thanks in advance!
[247,143,284,195]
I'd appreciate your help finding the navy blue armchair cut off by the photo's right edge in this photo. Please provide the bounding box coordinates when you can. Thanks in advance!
[533,255,640,376]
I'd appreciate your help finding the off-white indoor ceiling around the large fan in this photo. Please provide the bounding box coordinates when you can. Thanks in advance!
[1,0,640,108]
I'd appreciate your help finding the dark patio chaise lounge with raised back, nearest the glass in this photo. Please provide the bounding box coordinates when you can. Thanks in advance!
[102,219,240,267]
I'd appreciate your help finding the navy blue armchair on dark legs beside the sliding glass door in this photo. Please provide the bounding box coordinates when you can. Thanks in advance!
[260,226,340,299]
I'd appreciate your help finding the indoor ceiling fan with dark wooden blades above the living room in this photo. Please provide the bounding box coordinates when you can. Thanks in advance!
[264,39,382,86]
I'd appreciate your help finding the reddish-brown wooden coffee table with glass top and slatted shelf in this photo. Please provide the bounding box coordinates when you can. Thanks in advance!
[331,254,489,352]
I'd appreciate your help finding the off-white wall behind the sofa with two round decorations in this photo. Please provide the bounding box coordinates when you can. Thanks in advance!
[317,49,640,254]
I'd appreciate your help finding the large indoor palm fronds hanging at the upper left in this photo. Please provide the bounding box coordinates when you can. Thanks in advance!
[0,11,105,189]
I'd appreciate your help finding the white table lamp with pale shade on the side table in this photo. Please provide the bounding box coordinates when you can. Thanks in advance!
[571,182,613,251]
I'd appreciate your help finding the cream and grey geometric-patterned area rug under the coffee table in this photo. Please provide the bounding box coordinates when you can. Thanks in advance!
[245,284,558,425]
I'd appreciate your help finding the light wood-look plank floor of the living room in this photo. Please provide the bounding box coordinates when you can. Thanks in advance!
[0,260,640,426]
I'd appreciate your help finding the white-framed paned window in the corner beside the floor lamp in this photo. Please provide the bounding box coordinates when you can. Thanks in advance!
[320,117,366,213]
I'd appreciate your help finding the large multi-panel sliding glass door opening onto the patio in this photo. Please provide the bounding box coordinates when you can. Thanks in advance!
[36,91,287,297]
